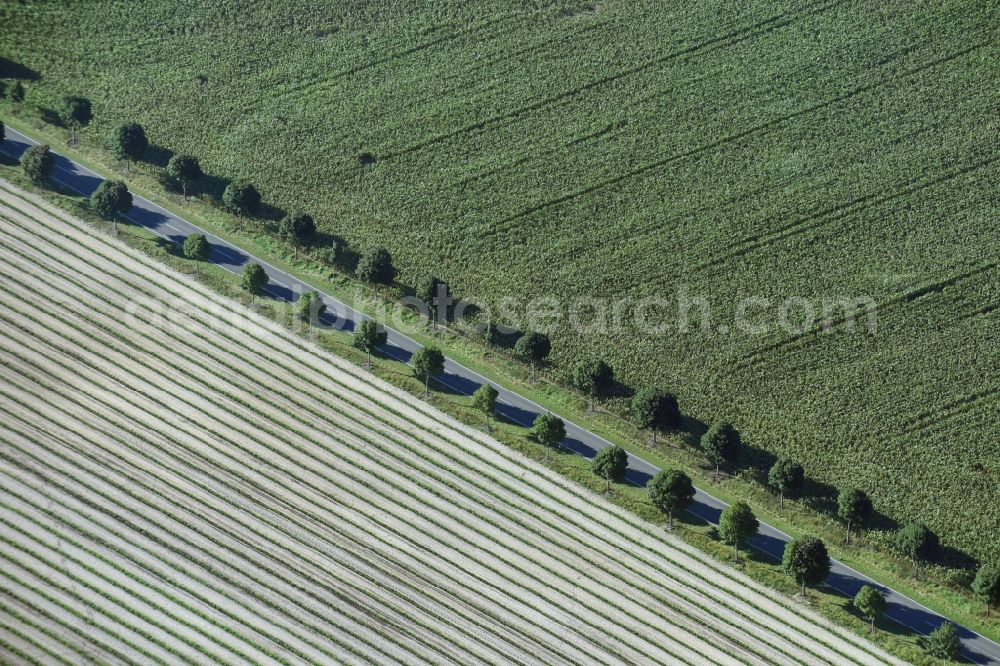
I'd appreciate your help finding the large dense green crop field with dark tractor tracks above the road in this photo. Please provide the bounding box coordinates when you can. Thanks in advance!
[0,0,1000,557]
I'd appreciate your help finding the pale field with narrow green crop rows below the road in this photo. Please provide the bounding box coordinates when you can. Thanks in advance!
[0,183,894,665]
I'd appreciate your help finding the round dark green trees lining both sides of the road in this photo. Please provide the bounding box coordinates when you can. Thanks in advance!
[11,94,1000,644]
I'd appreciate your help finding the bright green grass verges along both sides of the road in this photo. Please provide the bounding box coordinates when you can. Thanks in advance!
[3,121,1000,660]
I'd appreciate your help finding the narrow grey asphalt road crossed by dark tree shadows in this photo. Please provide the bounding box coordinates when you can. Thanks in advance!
[0,127,1000,664]
